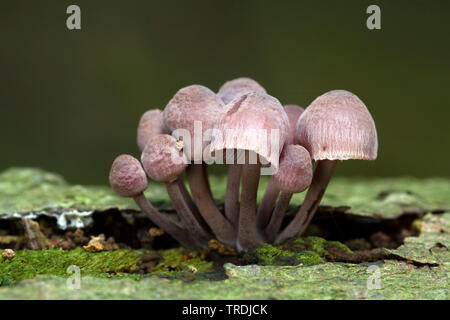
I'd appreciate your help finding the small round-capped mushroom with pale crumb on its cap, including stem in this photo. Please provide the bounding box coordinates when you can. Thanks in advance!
[141,134,212,247]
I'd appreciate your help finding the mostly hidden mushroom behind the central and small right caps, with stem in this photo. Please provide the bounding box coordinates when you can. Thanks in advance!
[256,104,304,229]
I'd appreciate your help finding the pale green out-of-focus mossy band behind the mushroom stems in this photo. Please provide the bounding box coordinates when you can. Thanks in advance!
[0,168,450,219]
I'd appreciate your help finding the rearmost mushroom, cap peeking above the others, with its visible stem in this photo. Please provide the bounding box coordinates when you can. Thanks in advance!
[217,77,266,226]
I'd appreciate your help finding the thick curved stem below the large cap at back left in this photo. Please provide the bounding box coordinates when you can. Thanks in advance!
[187,164,236,245]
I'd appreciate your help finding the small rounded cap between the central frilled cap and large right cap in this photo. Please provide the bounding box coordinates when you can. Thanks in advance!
[272,144,312,193]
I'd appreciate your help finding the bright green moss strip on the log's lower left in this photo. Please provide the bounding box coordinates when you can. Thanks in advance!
[0,248,140,286]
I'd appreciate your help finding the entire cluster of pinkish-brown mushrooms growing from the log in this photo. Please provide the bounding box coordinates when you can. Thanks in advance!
[109,78,378,252]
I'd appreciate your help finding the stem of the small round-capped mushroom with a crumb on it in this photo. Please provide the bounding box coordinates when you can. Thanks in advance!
[166,179,212,247]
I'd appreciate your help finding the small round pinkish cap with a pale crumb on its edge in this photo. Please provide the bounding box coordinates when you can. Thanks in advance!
[141,134,187,183]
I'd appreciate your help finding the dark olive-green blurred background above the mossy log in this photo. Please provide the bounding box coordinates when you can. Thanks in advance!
[0,0,450,184]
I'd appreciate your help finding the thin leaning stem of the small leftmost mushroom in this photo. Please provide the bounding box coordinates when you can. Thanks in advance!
[133,193,197,249]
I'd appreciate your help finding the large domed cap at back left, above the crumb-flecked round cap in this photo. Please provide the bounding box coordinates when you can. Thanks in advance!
[163,84,224,159]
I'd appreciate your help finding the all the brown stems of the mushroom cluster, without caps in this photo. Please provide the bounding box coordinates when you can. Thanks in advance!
[126,150,324,252]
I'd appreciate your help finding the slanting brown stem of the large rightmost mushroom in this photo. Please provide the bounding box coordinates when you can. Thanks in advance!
[275,160,337,242]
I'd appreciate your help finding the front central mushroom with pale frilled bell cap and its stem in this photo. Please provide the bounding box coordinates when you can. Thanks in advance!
[211,92,288,251]
